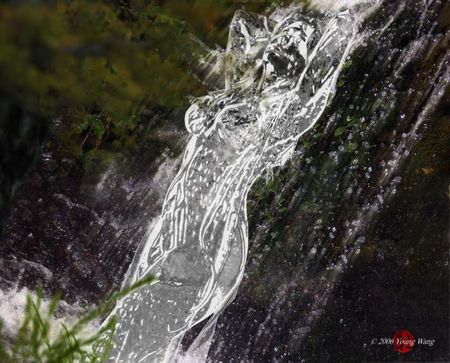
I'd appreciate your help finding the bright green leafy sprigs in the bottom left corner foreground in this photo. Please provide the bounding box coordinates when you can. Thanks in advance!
[0,276,155,363]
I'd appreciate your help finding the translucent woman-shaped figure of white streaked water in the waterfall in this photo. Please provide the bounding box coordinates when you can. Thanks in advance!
[111,8,354,362]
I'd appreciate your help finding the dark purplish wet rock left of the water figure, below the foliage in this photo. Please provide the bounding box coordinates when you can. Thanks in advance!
[0,118,183,305]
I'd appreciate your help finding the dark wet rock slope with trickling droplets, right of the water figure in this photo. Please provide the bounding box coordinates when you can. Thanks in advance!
[210,1,450,362]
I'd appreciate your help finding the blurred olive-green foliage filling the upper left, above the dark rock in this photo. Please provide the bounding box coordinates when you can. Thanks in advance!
[0,0,298,157]
